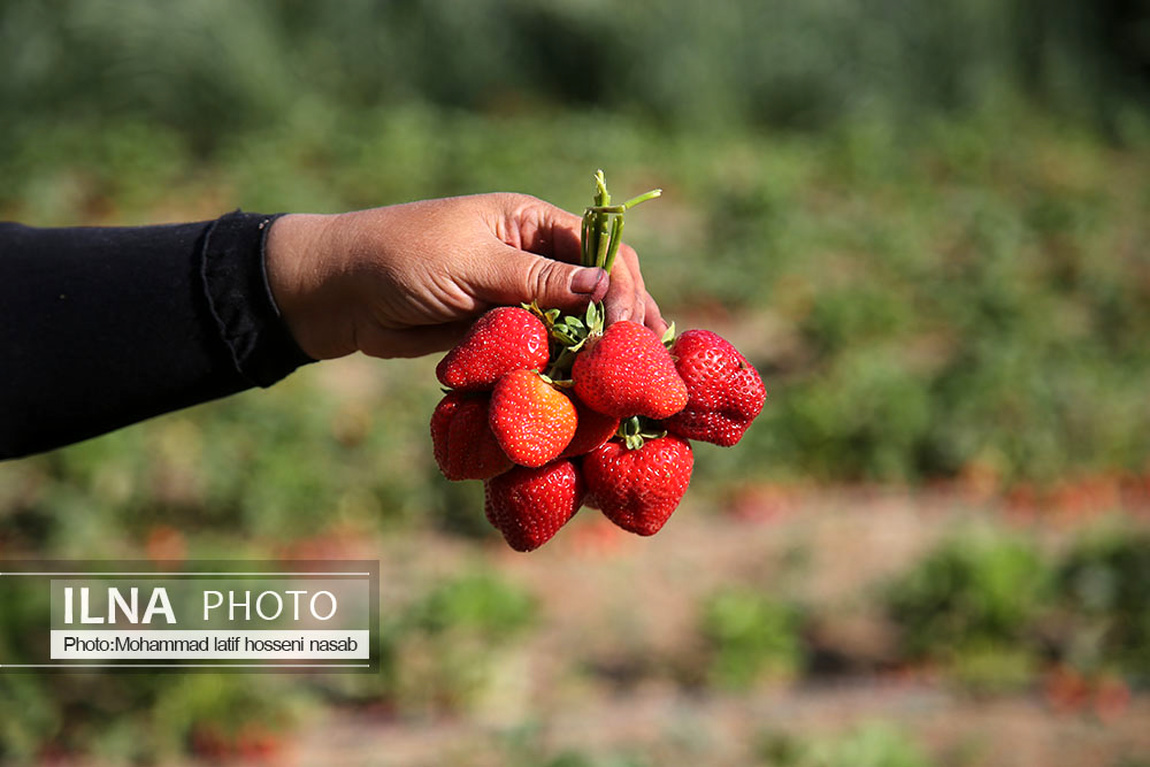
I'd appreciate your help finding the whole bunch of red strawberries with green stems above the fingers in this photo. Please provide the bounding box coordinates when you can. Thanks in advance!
[431,171,766,551]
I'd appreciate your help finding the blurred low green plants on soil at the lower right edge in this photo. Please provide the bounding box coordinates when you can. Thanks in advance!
[883,523,1150,691]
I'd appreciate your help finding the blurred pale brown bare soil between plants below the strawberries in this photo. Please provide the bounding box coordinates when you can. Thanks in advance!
[280,491,1150,767]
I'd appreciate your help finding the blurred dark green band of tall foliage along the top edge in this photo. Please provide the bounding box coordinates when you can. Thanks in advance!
[0,0,1150,149]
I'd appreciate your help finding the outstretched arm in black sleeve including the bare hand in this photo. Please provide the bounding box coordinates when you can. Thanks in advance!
[0,193,666,459]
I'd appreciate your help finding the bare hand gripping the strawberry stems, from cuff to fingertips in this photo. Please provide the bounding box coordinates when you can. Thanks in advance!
[266,194,666,359]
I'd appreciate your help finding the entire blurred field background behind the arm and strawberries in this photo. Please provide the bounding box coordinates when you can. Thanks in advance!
[0,0,1150,767]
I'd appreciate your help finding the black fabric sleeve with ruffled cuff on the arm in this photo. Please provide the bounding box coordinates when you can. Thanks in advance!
[0,212,312,459]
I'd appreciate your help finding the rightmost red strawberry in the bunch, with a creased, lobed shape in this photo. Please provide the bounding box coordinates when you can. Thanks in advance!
[665,330,767,447]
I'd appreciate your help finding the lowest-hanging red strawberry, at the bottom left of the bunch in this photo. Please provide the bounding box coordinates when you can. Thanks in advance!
[483,460,584,551]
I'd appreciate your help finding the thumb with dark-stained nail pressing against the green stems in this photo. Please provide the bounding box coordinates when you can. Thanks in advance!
[475,249,611,310]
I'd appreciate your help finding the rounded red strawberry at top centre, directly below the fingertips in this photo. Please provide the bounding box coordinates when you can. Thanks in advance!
[572,320,687,419]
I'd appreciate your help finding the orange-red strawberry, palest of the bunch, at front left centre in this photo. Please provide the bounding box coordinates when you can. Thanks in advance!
[489,370,577,466]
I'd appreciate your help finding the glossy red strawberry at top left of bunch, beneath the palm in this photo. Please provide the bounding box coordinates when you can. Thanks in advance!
[435,306,549,390]
